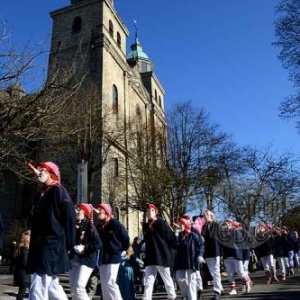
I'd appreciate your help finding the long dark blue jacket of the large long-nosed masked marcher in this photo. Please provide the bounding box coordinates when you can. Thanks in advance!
[27,183,76,276]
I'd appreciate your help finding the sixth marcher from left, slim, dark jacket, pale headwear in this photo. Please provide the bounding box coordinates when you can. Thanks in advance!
[202,210,223,300]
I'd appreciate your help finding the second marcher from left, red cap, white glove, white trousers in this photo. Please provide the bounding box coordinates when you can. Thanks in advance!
[70,203,102,300]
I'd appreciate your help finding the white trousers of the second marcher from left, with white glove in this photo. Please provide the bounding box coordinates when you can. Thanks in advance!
[70,262,93,300]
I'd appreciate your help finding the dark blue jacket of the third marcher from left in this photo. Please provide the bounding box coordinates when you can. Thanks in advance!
[97,218,130,264]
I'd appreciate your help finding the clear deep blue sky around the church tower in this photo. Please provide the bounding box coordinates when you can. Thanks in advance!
[0,0,300,154]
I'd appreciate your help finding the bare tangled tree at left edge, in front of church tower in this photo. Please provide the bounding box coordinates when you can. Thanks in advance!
[0,22,80,178]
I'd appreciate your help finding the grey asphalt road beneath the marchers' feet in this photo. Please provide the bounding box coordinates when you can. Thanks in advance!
[0,267,300,300]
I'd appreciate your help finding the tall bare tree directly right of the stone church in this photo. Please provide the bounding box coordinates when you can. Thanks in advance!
[167,102,235,214]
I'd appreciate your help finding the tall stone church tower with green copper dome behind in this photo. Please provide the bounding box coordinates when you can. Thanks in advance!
[49,0,166,238]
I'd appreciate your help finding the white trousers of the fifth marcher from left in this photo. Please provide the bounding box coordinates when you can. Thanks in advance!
[176,269,197,300]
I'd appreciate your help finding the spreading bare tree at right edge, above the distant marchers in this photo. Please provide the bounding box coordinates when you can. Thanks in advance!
[220,147,300,228]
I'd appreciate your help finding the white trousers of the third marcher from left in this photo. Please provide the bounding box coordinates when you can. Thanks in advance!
[100,264,122,300]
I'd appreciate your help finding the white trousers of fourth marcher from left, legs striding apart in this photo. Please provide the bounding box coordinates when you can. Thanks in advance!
[143,266,176,300]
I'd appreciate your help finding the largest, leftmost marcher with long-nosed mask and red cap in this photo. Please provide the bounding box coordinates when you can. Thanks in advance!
[27,162,76,300]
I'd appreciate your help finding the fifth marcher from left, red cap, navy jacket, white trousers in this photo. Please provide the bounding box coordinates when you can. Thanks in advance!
[173,218,204,300]
